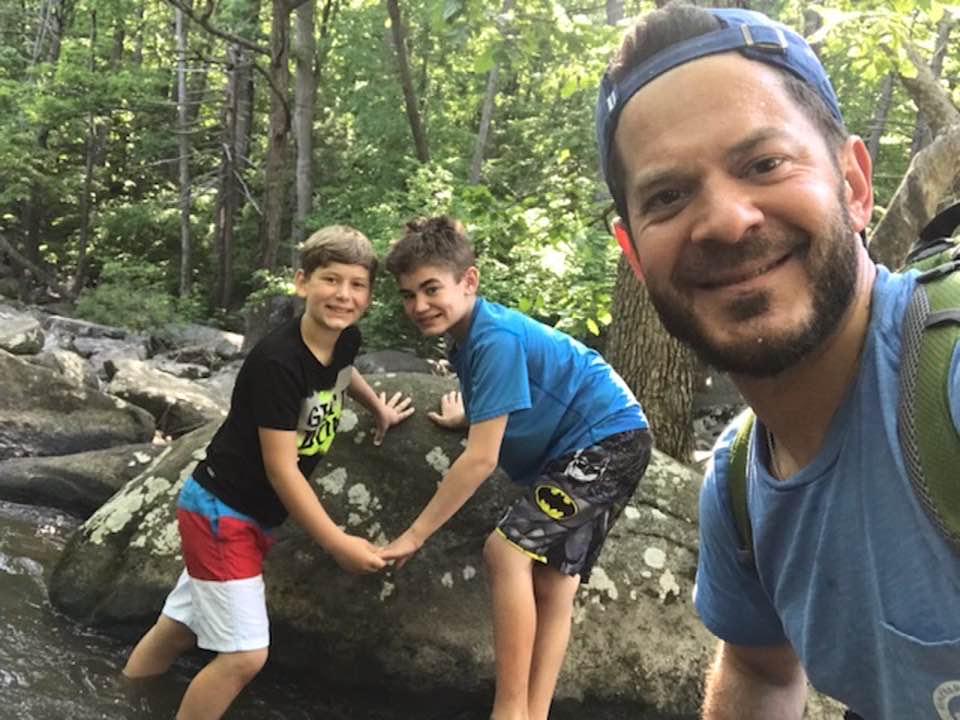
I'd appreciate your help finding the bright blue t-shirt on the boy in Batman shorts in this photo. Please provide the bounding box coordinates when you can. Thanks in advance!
[450,298,647,485]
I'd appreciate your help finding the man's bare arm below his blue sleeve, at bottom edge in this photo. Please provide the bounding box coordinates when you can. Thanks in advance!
[703,642,807,720]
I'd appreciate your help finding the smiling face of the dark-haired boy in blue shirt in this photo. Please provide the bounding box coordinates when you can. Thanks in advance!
[397,265,480,340]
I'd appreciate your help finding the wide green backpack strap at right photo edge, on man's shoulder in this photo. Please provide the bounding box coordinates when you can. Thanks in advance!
[897,246,960,552]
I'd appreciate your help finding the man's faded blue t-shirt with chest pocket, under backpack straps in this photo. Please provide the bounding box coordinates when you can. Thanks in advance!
[695,267,960,720]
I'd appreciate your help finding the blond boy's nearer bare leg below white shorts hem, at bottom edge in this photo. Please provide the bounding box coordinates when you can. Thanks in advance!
[177,648,268,720]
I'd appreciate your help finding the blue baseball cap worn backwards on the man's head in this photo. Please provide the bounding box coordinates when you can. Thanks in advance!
[597,8,843,190]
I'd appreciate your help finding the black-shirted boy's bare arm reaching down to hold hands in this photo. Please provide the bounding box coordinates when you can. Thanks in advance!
[257,427,385,572]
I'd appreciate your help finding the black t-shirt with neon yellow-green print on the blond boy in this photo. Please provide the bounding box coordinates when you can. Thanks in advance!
[194,317,360,526]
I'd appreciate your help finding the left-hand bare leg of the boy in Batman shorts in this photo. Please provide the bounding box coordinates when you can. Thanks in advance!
[483,532,537,720]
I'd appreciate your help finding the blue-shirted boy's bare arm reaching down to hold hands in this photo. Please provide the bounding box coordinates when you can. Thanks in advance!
[380,415,508,567]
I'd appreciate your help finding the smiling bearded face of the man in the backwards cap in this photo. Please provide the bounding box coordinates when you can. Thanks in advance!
[615,53,863,376]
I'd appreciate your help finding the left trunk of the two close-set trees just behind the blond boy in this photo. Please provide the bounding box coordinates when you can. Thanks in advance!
[260,0,291,270]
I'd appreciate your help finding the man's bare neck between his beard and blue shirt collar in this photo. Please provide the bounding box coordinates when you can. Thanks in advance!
[731,250,877,474]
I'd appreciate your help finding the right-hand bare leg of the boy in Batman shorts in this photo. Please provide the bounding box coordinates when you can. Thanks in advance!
[529,563,580,720]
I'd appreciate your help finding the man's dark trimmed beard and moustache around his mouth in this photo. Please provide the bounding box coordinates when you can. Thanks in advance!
[648,196,857,377]
